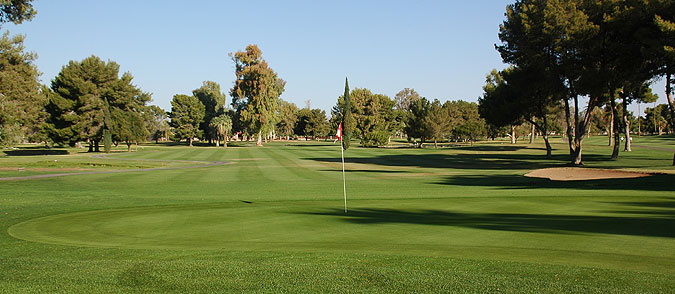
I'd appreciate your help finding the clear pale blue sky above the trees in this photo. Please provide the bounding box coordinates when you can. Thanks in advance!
[3,0,665,115]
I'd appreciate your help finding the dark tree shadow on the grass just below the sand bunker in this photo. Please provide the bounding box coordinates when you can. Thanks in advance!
[436,174,675,192]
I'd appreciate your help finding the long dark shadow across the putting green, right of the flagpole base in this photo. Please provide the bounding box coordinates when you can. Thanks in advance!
[305,209,675,238]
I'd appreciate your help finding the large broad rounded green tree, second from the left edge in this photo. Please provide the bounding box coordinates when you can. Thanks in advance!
[45,55,151,151]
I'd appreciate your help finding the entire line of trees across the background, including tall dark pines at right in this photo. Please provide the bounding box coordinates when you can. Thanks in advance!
[0,0,675,158]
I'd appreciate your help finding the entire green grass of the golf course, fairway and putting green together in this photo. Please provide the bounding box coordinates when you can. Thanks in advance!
[0,137,675,293]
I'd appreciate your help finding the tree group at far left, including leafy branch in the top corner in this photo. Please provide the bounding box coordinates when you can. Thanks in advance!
[0,0,162,151]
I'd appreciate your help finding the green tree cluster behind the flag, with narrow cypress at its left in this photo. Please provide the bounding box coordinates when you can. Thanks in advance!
[331,84,487,148]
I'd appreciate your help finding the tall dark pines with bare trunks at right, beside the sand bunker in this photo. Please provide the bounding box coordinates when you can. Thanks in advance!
[479,0,675,164]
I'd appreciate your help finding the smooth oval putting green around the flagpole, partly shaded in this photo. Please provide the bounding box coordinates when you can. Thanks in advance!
[8,198,675,271]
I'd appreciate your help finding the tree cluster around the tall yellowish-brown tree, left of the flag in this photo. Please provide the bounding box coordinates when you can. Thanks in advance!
[169,45,330,146]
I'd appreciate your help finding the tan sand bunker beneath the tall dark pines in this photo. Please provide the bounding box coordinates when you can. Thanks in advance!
[525,167,651,181]
